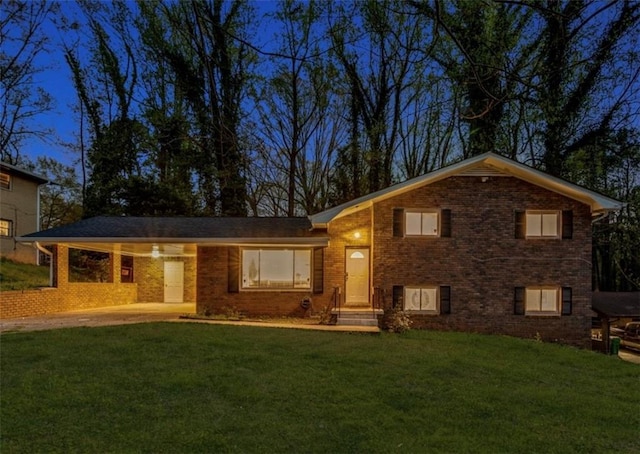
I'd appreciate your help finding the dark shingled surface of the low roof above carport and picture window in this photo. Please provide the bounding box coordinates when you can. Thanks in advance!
[18,216,326,243]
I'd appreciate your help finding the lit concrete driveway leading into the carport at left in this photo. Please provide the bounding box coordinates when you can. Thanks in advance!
[0,303,195,333]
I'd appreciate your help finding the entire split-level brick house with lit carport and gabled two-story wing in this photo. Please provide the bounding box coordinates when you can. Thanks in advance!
[16,153,621,347]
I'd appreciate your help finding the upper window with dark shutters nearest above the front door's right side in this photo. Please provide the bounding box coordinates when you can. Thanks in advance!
[393,208,451,237]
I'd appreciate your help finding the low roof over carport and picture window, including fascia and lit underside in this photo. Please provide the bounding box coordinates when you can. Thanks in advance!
[16,216,329,255]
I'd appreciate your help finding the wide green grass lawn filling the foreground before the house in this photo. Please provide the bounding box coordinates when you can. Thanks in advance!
[0,323,640,454]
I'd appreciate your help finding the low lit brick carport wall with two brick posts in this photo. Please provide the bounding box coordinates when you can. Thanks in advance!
[0,246,138,319]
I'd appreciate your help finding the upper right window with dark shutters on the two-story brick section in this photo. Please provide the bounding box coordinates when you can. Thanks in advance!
[515,210,573,239]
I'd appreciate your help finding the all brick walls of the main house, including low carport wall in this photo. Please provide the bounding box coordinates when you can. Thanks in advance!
[0,167,592,347]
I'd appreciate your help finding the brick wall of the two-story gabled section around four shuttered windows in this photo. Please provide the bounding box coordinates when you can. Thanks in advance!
[373,177,591,347]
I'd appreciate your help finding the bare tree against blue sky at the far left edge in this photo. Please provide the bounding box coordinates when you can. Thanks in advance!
[0,0,57,164]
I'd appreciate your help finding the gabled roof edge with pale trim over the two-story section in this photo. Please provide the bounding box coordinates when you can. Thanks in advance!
[310,153,623,227]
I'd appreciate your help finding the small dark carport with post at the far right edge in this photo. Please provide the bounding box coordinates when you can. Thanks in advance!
[591,292,640,354]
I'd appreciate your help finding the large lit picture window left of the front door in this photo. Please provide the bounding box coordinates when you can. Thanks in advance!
[242,249,311,289]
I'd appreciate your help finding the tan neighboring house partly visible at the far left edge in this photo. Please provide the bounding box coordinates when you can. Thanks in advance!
[0,162,48,264]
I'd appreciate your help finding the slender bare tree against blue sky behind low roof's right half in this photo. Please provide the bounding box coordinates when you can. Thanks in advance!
[256,0,342,216]
